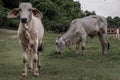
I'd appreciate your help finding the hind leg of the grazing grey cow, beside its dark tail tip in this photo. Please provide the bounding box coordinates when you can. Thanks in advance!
[99,33,109,56]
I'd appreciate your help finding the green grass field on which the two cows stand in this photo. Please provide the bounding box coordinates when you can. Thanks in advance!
[0,29,120,80]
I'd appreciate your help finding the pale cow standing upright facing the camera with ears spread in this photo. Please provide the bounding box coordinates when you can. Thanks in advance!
[7,3,44,76]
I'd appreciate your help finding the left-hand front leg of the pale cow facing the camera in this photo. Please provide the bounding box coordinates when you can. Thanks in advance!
[22,51,27,76]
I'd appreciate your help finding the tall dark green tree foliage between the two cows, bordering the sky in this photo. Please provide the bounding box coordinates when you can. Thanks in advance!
[34,0,81,32]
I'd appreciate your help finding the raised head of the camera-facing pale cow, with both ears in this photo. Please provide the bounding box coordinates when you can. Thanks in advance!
[7,3,42,23]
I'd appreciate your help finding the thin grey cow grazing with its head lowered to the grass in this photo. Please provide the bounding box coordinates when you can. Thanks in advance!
[56,15,109,55]
